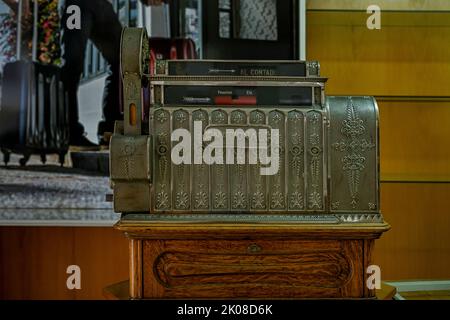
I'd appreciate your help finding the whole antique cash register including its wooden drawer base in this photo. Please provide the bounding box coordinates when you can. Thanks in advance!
[110,28,389,298]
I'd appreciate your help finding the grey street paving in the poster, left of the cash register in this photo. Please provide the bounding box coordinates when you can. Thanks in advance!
[0,155,119,221]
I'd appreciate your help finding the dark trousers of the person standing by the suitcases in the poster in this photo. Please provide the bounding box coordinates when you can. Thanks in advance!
[61,0,122,137]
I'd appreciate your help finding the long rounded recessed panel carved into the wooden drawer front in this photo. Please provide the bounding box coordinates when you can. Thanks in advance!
[153,251,353,289]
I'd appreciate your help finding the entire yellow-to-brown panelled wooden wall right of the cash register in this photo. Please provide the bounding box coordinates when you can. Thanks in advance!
[307,8,450,280]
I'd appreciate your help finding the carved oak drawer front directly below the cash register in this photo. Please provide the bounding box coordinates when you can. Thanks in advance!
[143,240,363,298]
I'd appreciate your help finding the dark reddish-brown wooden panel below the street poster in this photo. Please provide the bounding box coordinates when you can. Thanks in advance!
[0,227,128,299]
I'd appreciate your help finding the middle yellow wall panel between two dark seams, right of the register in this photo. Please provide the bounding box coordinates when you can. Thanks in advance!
[378,100,450,181]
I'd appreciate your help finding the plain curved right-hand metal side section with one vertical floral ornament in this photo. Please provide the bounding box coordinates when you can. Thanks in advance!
[327,97,379,213]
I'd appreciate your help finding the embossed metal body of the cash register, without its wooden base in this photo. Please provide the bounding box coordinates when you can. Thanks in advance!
[111,26,382,222]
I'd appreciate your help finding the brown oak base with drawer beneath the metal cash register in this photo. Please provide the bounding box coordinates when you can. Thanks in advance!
[116,221,389,299]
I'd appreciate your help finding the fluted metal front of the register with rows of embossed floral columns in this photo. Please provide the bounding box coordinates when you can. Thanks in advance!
[150,106,326,212]
